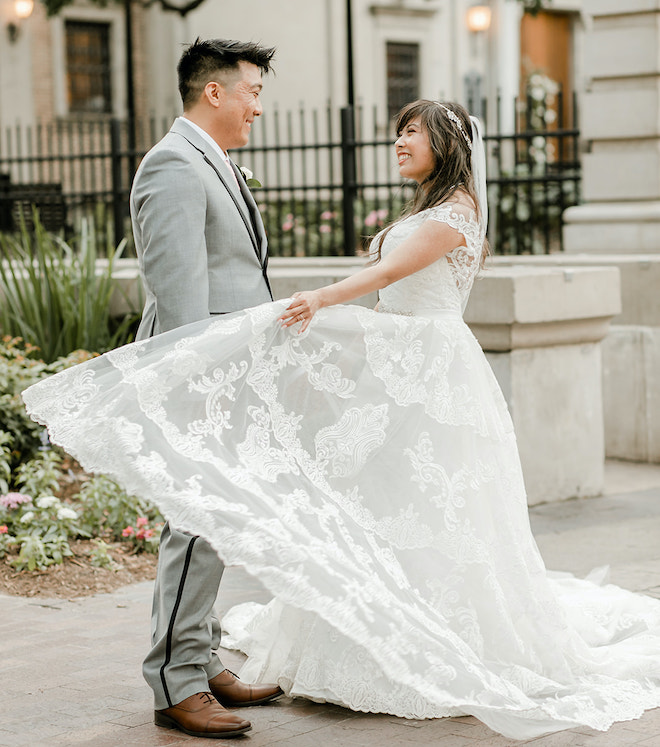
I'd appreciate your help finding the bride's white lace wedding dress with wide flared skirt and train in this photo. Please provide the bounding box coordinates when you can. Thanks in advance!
[24,205,660,739]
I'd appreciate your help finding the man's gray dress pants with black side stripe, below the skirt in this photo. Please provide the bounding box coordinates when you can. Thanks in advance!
[142,524,224,710]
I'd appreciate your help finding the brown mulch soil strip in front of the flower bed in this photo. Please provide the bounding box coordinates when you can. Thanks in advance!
[0,540,158,599]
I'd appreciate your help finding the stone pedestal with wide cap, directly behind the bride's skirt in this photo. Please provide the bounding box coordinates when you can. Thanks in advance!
[465,265,621,505]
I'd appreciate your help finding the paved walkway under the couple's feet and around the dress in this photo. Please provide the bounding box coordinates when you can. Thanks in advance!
[0,463,660,747]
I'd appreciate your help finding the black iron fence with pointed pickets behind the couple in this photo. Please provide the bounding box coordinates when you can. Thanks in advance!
[0,97,580,256]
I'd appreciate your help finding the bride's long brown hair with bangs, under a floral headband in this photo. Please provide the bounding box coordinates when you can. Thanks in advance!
[370,99,479,262]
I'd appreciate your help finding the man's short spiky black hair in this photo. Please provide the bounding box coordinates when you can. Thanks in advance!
[177,38,275,109]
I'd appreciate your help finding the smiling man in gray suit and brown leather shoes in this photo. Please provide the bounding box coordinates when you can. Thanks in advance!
[131,39,281,738]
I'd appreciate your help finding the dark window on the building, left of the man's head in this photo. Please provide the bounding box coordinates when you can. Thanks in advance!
[66,21,112,114]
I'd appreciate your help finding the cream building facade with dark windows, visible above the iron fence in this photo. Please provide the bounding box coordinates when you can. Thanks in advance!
[0,0,583,129]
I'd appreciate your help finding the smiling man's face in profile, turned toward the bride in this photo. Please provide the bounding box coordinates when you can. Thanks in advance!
[215,62,263,150]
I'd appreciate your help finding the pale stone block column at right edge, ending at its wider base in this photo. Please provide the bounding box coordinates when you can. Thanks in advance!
[564,0,660,253]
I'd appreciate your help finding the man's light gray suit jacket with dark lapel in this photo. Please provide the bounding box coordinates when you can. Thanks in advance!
[130,118,272,340]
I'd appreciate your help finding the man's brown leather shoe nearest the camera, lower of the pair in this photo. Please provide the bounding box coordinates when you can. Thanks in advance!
[154,693,252,739]
